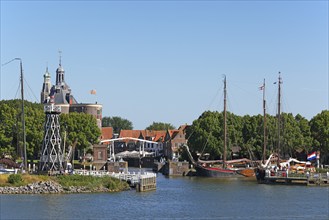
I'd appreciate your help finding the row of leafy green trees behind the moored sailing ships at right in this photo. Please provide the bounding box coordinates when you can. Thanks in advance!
[187,111,329,163]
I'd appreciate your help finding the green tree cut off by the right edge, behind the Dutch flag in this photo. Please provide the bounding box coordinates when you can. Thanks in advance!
[310,110,329,163]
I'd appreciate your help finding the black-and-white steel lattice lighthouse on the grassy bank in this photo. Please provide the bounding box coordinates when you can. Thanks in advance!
[39,104,64,173]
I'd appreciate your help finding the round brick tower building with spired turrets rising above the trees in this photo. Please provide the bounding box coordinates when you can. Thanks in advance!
[40,59,103,129]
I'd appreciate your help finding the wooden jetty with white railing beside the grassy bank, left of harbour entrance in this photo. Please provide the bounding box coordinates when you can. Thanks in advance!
[74,170,156,192]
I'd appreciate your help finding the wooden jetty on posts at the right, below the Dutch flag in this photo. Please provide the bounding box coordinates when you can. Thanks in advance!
[264,171,329,186]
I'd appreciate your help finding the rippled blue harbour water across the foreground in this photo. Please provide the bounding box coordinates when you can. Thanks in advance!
[0,174,329,220]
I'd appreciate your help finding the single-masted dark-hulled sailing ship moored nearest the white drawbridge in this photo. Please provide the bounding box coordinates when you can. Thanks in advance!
[185,76,255,178]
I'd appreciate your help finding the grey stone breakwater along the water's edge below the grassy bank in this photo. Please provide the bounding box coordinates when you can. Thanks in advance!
[0,181,109,194]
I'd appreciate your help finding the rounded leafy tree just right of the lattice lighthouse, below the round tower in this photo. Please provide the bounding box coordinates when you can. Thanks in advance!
[60,112,101,150]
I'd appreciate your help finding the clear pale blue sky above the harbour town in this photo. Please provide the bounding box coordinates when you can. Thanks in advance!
[0,0,329,129]
